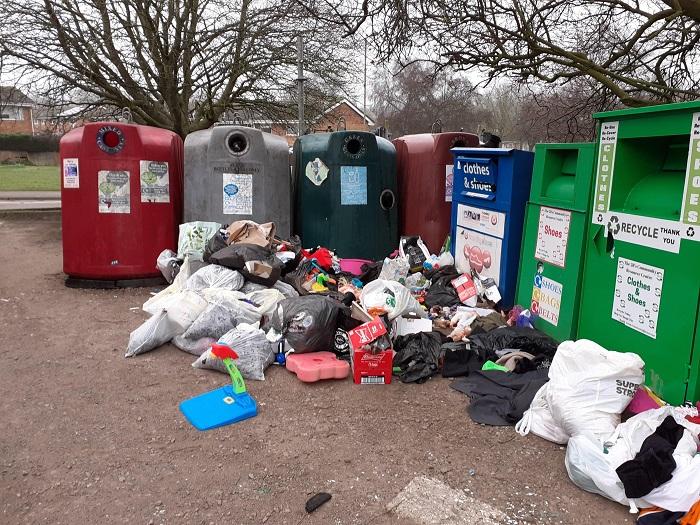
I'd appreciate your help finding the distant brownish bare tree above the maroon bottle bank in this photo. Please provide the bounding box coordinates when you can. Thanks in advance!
[372,63,485,136]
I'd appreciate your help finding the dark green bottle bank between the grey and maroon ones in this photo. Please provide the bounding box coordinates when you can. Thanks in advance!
[294,131,399,260]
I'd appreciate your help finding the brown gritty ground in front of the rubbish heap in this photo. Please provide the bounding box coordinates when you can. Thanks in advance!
[0,212,633,524]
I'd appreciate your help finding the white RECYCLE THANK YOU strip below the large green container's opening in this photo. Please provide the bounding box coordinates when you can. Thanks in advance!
[604,211,684,253]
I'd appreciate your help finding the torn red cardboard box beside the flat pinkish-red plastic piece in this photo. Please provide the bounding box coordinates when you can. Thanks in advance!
[348,318,394,385]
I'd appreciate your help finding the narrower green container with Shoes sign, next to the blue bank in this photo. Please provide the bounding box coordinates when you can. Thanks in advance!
[517,143,595,341]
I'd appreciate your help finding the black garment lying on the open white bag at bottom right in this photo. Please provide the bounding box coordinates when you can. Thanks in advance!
[615,416,683,498]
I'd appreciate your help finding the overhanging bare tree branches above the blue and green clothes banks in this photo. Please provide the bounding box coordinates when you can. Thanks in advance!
[298,0,700,106]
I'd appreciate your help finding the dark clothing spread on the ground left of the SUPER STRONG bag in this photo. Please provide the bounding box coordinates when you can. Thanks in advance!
[450,370,549,426]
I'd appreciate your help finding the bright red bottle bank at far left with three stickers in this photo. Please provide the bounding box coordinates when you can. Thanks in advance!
[59,122,183,281]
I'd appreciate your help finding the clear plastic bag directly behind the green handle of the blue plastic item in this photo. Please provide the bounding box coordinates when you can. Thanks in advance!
[192,324,275,381]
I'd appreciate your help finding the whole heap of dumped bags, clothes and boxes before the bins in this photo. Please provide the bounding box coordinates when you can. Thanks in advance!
[126,221,700,515]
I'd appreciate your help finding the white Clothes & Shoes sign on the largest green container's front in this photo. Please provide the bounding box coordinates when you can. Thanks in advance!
[612,257,664,339]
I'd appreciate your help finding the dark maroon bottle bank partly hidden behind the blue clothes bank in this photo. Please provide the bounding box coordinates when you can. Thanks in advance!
[393,132,479,254]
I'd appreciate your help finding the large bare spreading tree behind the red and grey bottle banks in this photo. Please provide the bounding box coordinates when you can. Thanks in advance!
[0,0,354,136]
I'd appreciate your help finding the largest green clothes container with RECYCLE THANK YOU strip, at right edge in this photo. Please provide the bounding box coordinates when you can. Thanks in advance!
[578,101,700,404]
